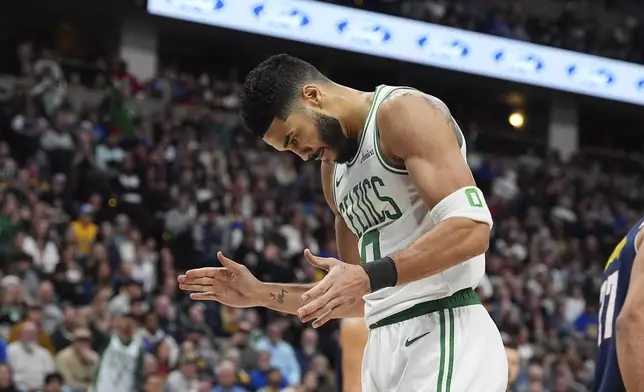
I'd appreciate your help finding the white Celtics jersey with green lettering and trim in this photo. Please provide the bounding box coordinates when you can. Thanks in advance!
[333,86,485,325]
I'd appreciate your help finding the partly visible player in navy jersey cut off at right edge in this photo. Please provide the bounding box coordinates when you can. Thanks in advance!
[595,219,644,392]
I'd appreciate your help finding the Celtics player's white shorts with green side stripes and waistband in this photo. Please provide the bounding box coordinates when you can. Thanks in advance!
[362,289,508,392]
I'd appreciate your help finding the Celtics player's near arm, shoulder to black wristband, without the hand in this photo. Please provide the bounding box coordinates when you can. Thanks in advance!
[378,94,492,284]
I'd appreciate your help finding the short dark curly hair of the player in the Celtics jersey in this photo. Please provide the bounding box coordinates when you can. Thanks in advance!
[240,54,329,137]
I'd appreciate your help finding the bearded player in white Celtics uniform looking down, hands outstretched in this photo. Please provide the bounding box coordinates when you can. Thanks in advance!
[179,55,508,392]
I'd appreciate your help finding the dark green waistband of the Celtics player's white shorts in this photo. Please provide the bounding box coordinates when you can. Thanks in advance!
[369,288,481,329]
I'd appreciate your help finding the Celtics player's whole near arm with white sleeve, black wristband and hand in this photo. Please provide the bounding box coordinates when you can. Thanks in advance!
[298,94,492,326]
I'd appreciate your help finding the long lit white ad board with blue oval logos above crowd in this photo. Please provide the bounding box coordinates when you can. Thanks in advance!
[147,0,644,105]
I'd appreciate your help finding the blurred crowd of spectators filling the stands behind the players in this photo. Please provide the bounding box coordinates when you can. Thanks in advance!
[0,36,644,392]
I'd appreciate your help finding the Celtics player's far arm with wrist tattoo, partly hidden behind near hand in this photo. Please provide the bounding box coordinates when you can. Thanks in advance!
[179,163,364,322]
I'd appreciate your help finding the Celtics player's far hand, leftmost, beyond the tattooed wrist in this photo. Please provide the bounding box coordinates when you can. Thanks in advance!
[178,252,261,308]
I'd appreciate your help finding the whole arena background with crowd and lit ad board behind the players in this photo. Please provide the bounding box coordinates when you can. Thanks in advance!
[0,0,644,392]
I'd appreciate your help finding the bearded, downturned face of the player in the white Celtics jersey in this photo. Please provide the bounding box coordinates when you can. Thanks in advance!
[264,108,358,163]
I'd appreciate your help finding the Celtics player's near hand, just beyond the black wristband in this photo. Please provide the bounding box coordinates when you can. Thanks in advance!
[297,249,371,328]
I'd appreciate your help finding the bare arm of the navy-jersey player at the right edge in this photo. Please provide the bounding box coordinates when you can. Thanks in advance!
[616,229,644,391]
